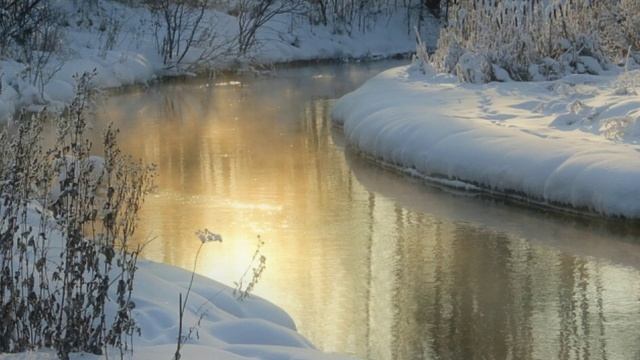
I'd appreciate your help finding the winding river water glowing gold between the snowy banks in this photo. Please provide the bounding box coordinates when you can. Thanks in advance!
[97,61,640,359]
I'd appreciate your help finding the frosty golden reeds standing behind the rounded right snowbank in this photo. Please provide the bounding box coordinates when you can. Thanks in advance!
[432,0,608,82]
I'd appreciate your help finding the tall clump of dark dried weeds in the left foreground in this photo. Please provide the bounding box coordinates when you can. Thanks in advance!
[0,74,153,358]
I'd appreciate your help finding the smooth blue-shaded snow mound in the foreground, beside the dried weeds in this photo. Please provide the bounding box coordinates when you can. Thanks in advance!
[0,201,348,360]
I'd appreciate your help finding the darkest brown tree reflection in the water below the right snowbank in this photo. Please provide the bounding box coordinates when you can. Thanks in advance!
[425,226,530,359]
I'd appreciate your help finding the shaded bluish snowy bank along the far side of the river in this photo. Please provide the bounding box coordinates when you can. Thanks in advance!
[0,0,438,120]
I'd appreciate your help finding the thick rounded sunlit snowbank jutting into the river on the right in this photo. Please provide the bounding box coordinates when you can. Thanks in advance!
[333,63,640,218]
